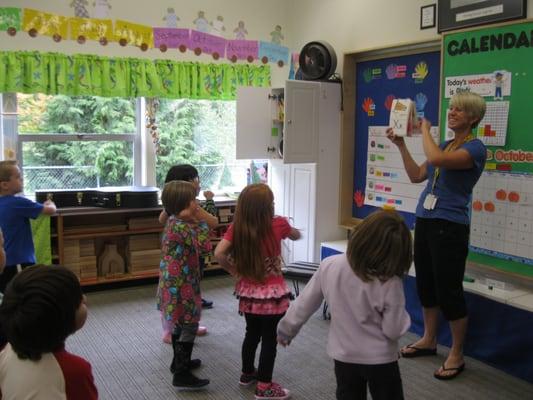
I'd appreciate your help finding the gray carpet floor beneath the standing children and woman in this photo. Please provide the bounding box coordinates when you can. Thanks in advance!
[67,277,533,400]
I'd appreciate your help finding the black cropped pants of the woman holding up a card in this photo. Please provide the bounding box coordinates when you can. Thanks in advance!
[414,218,470,321]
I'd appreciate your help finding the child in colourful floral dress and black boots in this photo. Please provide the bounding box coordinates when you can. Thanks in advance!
[157,181,211,388]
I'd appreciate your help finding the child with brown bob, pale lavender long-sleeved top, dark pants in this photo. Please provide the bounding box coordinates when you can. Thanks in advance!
[278,210,413,400]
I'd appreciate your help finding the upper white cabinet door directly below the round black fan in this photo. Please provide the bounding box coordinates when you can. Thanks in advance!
[283,81,320,163]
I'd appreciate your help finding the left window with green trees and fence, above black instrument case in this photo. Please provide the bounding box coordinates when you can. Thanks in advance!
[17,94,140,194]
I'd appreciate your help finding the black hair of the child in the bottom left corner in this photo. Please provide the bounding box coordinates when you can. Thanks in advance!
[0,265,83,361]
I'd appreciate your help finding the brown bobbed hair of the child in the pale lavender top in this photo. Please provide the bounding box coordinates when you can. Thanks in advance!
[346,210,413,282]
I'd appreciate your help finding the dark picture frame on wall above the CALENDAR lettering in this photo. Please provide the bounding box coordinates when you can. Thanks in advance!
[437,0,527,33]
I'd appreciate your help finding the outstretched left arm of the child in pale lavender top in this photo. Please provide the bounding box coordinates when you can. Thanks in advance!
[278,267,324,346]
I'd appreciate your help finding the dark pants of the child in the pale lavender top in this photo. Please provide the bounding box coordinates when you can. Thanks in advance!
[335,360,403,400]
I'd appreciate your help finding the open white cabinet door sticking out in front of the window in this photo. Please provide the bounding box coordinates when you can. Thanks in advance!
[236,87,281,160]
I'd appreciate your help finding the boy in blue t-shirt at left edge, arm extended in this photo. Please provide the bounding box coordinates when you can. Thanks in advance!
[0,160,56,293]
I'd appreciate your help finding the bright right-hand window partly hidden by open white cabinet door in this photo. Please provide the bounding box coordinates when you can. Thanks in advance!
[156,99,266,193]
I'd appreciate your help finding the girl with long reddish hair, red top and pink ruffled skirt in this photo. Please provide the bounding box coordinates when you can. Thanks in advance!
[215,183,300,399]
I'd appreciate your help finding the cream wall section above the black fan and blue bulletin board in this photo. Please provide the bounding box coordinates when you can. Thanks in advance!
[289,0,533,73]
